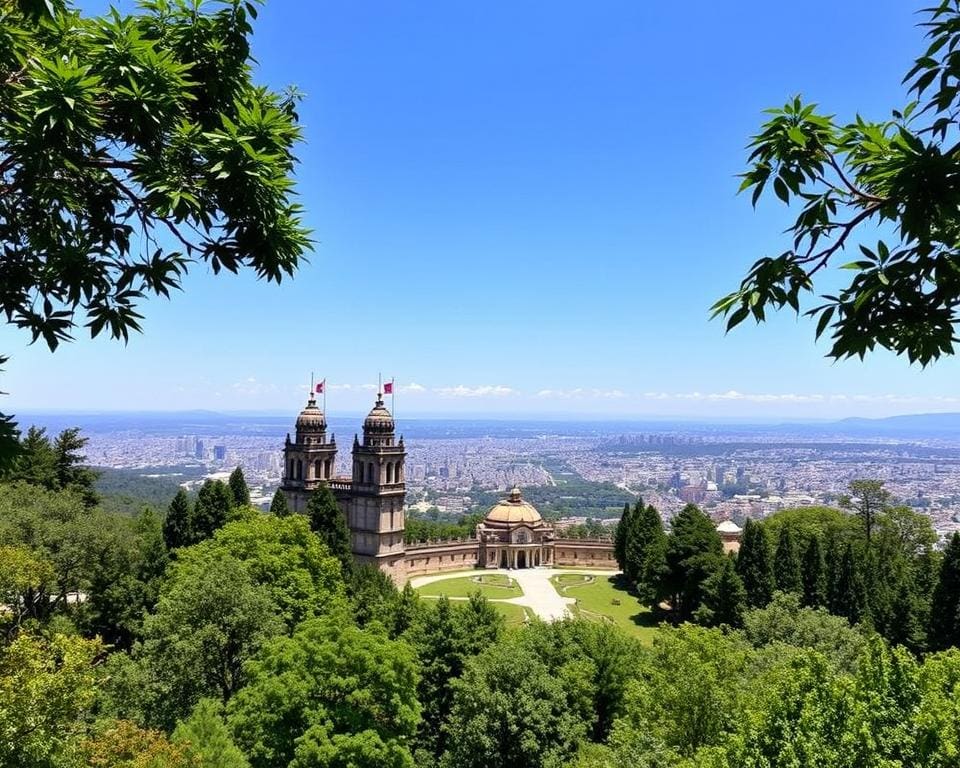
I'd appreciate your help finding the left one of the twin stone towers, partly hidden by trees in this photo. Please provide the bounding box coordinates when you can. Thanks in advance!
[280,393,337,512]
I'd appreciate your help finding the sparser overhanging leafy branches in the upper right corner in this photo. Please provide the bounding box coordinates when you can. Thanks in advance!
[713,0,960,365]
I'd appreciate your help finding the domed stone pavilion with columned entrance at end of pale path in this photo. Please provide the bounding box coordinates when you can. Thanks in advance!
[477,488,554,568]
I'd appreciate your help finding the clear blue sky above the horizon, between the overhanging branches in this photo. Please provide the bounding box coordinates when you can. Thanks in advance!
[7,0,960,418]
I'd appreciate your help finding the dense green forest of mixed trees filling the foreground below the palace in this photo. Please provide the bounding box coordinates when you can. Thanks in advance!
[0,434,960,768]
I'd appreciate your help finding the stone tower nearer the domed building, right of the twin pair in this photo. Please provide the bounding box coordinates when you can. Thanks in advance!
[344,393,406,583]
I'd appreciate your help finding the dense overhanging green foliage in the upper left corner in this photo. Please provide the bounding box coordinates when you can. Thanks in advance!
[0,0,310,464]
